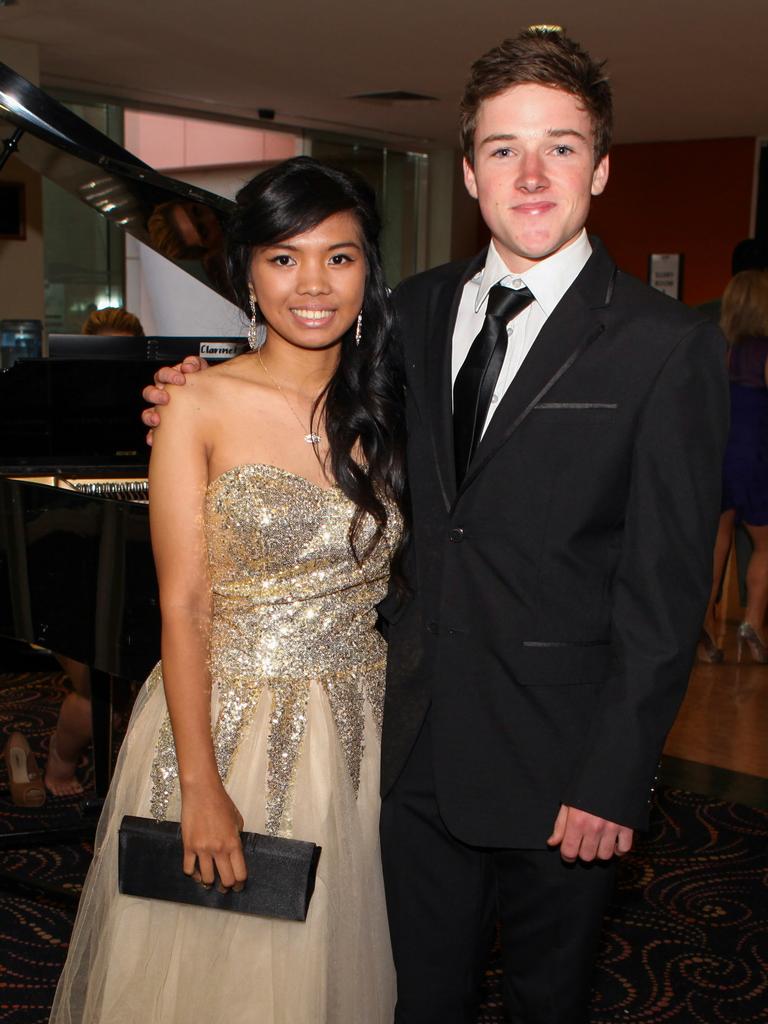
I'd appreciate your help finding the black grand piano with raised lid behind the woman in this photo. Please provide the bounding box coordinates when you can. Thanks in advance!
[0,63,244,849]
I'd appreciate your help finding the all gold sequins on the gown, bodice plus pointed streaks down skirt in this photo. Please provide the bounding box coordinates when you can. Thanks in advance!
[152,464,399,835]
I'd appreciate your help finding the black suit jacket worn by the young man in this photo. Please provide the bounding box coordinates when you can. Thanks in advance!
[382,240,727,848]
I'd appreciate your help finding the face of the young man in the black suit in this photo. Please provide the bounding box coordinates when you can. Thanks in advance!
[464,84,608,273]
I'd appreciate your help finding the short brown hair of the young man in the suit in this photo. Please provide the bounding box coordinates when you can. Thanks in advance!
[460,28,613,165]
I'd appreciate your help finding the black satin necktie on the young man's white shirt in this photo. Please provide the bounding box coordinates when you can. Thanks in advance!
[454,285,534,483]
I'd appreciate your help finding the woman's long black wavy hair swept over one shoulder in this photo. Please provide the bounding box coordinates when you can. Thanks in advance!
[226,157,406,561]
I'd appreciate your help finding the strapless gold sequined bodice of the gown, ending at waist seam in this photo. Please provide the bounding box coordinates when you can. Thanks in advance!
[206,465,389,679]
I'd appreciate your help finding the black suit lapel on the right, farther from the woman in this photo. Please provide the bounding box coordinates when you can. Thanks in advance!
[459,239,616,494]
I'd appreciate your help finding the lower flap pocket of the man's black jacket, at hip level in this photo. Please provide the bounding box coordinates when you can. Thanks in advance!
[515,640,611,686]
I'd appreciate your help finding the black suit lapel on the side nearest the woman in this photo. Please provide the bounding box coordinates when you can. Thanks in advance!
[424,252,485,509]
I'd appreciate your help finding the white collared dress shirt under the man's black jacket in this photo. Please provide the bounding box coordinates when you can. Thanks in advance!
[451,228,592,433]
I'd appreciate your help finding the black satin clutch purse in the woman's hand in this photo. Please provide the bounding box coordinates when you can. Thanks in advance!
[118,814,321,921]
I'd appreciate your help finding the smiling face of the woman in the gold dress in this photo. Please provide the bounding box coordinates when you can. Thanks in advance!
[251,212,366,349]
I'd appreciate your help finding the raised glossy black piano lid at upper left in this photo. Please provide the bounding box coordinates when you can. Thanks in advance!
[0,62,234,301]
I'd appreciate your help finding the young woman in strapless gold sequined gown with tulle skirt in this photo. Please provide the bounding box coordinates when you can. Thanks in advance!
[51,158,403,1024]
